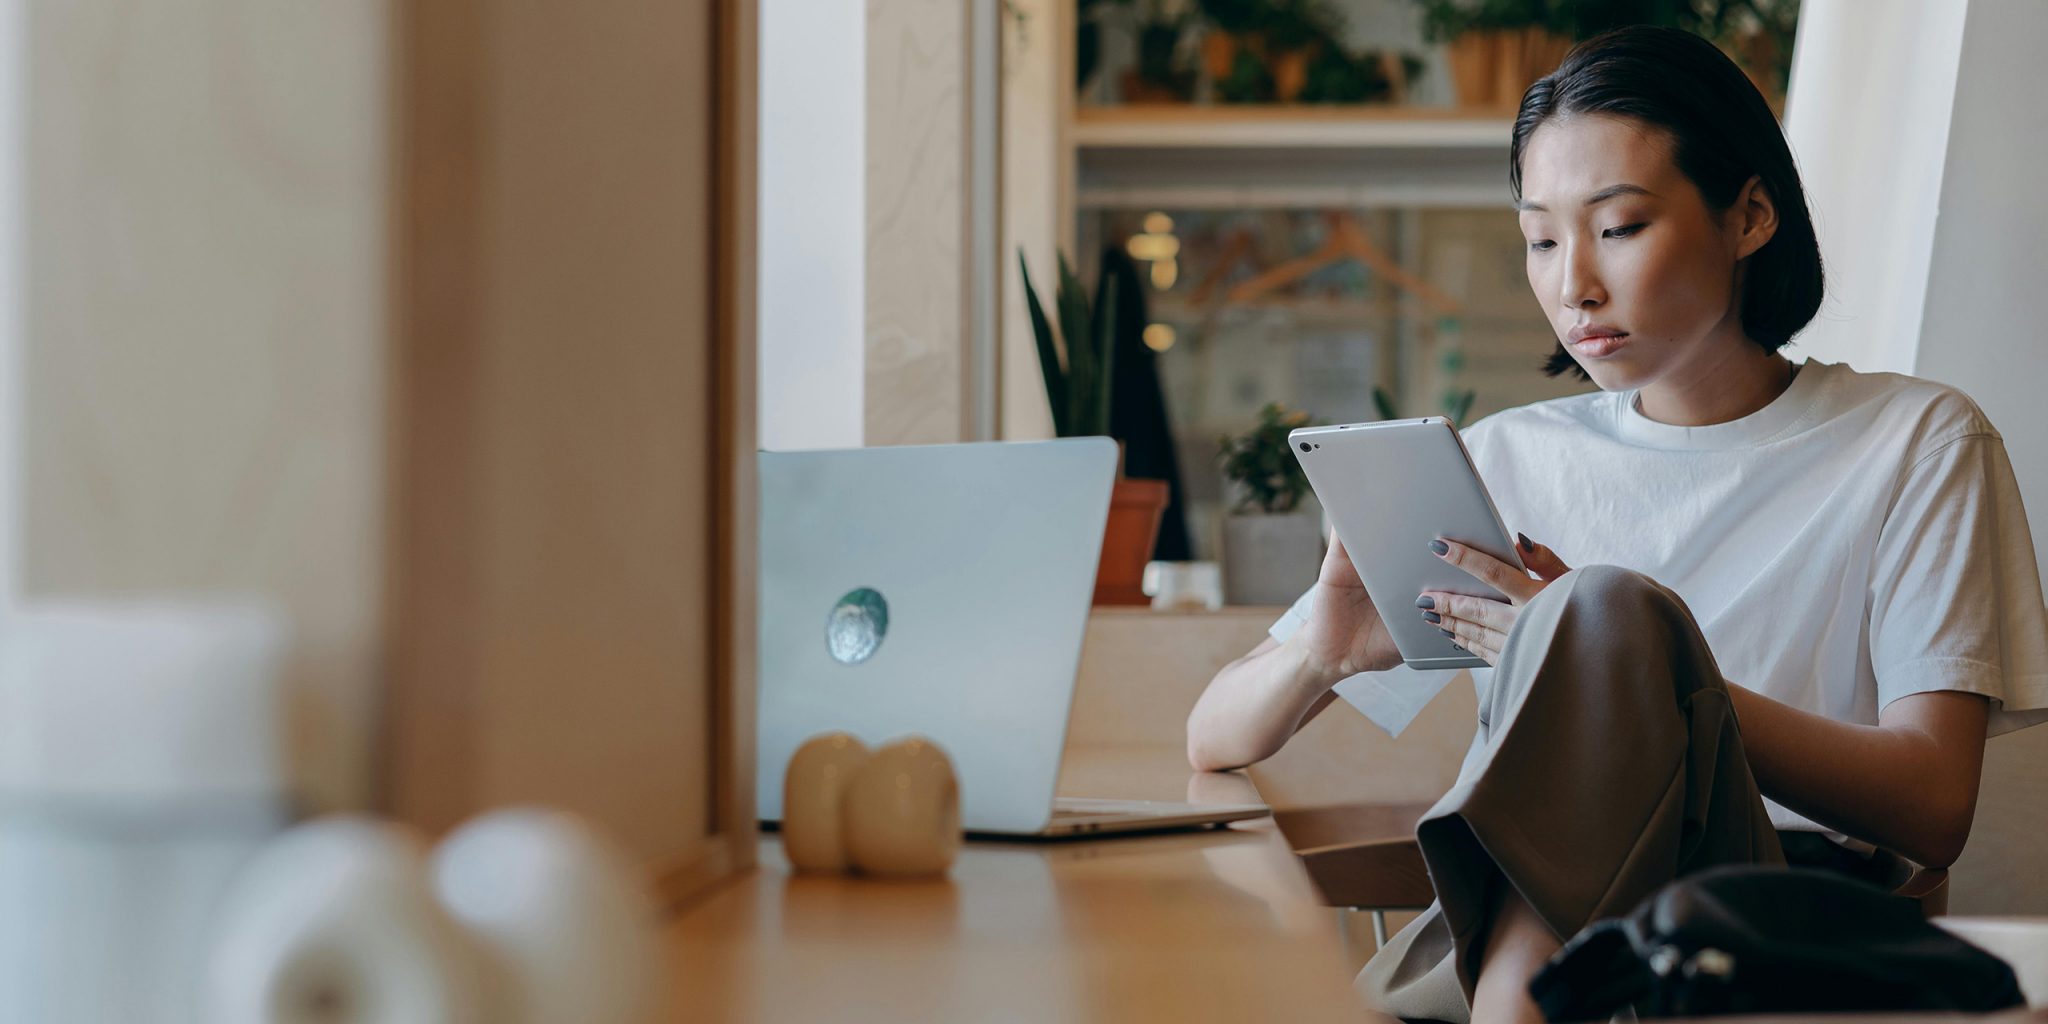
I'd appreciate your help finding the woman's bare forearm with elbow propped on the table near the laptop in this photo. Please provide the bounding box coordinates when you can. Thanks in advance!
[1188,639,1337,772]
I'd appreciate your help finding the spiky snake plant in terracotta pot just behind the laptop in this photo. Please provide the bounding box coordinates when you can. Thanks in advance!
[1018,250,1169,604]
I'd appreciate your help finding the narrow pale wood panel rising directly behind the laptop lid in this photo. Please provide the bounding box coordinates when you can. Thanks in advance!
[864,0,969,444]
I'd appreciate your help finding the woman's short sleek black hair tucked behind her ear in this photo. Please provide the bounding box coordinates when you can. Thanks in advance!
[1507,25,1823,379]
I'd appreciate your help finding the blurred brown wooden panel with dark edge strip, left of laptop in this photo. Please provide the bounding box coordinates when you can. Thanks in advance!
[385,0,754,895]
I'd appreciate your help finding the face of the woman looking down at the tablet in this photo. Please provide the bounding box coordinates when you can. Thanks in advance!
[1518,115,1767,391]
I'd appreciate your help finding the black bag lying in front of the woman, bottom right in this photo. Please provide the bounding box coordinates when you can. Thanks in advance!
[1530,864,2023,1020]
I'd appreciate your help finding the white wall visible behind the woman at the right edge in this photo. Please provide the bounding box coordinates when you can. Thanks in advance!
[1786,0,2048,913]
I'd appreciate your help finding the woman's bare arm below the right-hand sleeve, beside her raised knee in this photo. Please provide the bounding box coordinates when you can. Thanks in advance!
[1729,684,1989,868]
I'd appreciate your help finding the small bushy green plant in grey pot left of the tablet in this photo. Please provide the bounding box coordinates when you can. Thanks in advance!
[1221,403,1323,604]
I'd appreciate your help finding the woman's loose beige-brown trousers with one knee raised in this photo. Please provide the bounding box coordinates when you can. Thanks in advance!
[1358,565,1784,1022]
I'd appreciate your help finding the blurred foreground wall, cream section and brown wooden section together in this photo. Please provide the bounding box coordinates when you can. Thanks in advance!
[8,0,756,897]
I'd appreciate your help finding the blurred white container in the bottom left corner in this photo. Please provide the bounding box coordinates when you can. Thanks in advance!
[0,602,289,1024]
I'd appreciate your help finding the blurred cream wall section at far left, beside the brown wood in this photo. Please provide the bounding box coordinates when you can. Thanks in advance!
[25,0,389,809]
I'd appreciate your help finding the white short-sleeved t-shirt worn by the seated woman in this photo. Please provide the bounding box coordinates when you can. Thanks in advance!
[1272,360,2048,829]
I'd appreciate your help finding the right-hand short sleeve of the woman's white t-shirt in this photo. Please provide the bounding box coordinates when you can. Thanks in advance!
[1870,434,2048,735]
